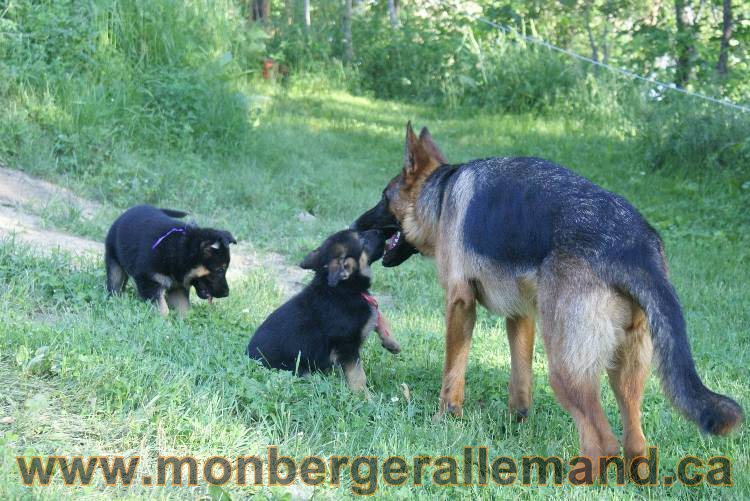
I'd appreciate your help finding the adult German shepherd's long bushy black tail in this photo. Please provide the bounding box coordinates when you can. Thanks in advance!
[598,251,743,435]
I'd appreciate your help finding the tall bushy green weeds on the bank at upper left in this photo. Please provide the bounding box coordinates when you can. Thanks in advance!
[0,0,265,170]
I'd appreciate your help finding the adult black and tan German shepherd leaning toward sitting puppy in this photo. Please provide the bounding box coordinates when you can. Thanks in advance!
[352,123,743,468]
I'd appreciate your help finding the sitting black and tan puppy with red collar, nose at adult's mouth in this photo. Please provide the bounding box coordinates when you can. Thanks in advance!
[247,230,400,392]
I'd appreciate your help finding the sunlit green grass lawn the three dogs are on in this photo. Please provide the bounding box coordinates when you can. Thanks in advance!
[0,89,750,499]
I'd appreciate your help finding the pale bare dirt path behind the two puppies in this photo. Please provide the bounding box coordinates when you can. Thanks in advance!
[0,166,306,296]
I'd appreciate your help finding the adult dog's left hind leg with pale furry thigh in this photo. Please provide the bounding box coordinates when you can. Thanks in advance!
[538,258,630,480]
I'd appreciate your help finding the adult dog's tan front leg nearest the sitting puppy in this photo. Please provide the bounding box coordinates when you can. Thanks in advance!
[435,282,477,419]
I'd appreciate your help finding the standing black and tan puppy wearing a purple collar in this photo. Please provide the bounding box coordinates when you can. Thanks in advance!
[104,205,237,315]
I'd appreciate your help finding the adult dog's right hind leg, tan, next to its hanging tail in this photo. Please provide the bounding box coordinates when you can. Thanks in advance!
[607,305,653,467]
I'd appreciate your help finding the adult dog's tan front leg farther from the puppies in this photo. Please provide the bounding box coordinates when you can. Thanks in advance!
[505,316,534,421]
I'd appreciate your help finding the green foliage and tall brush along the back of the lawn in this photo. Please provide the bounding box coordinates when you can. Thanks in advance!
[0,0,750,175]
